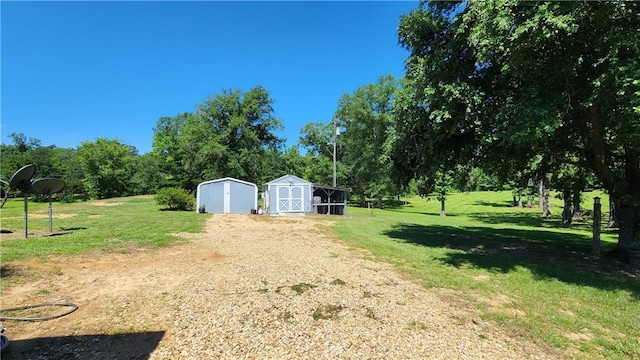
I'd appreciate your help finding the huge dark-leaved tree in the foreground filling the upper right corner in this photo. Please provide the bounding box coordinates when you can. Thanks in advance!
[399,0,640,264]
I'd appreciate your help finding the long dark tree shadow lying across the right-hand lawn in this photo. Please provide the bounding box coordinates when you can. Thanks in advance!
[383,224,640,298]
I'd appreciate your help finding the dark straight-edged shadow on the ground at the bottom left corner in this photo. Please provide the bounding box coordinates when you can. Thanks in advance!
[2,328,165,360]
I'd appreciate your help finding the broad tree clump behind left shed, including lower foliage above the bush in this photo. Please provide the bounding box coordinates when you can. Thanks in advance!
[152,86,283,190]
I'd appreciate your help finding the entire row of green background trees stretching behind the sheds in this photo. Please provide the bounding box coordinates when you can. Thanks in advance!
[0,81,509,203]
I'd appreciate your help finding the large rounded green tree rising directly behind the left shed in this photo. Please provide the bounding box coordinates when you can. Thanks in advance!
[180,86,283,190]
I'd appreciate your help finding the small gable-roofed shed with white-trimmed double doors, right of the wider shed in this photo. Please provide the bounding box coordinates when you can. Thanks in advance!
[263,175,313,215]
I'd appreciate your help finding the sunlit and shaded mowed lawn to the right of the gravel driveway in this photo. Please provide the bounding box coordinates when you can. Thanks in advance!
[335,192,640,359]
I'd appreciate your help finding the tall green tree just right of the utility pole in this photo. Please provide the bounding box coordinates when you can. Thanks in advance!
[336,75,400,207]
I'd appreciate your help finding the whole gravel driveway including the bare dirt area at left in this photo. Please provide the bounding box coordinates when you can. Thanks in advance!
[2,215,554,359]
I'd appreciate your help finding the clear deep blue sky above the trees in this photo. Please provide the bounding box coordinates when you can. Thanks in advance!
[0,1,418,153]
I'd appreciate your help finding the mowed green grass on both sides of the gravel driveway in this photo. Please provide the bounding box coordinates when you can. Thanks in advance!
[0,192,640,359]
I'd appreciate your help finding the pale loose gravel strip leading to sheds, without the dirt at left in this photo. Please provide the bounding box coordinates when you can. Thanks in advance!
[151,216,550,359]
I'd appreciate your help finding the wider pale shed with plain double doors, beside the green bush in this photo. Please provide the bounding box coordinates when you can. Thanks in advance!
[196,177,258,214]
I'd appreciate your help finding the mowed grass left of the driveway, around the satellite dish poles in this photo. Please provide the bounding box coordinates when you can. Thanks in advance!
[0,196,208,267]
